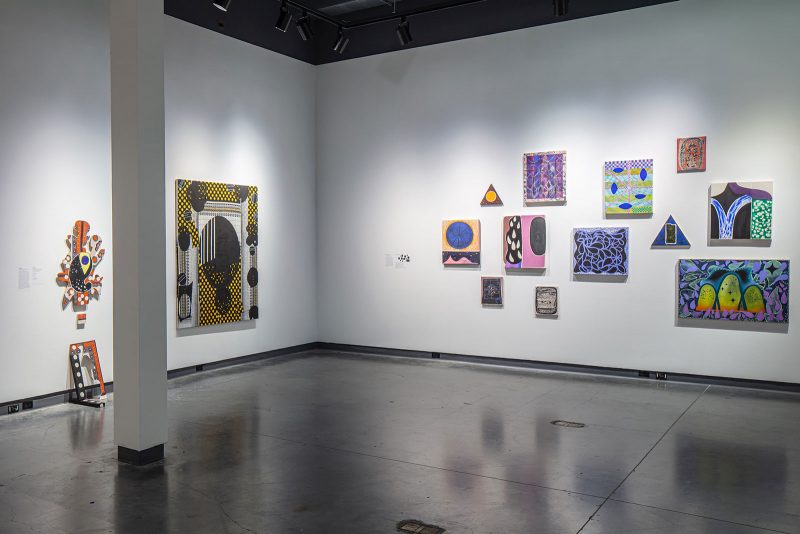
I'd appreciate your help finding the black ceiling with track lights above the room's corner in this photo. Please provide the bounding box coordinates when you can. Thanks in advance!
[164,0,677,65]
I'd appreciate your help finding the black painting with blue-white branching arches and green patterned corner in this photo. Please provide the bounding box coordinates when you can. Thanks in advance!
[708,182,772,240]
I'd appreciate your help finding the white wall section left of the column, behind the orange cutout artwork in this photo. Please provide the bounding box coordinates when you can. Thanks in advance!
[0,0,114,402]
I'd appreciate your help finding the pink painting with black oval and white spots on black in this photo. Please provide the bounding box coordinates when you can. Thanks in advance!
[503,215,547,269]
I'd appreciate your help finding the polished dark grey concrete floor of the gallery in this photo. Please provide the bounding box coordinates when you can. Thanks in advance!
[0,352,800,534]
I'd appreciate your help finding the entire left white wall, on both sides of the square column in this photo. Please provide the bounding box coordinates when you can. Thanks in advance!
[0,5,317,403]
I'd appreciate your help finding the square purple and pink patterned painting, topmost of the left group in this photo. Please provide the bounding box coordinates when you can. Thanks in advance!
[522,152,567,203]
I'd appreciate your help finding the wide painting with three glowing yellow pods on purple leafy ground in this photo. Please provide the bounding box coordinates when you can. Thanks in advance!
[678,260,789,323]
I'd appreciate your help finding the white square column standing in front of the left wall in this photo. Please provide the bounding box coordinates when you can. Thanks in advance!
[111,0,167,464]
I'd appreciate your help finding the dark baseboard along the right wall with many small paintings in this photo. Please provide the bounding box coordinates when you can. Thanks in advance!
[317,342,800,393]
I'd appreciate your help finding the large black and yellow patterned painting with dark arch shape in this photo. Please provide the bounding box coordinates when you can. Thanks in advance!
[175,179,258,328]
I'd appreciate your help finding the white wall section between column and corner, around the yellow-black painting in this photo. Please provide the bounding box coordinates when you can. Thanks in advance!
[164,17,317,369]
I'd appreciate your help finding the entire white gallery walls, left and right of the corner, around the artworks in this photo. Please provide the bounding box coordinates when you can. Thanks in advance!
[0,0,800,402]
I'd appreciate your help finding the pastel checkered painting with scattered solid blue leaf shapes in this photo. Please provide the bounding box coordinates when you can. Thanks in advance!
[604,159,653,215]
